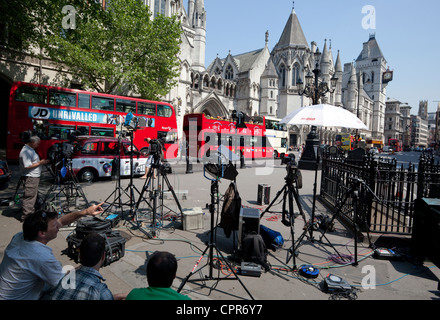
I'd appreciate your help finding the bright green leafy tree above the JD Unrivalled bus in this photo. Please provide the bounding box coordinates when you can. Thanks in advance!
[1,0,182,100]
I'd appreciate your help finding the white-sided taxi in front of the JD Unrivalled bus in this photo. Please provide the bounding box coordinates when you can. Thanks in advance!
[52,136,148,182]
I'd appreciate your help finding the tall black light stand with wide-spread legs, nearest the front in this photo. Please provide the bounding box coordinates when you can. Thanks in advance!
[177,172,254,300]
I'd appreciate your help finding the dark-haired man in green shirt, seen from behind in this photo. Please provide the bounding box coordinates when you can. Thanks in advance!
[126,251,191,300]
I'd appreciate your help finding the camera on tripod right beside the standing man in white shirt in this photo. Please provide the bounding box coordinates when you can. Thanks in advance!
[43,158,89,211]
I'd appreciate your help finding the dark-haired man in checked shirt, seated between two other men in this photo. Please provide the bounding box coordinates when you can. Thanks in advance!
[52,233,126,300]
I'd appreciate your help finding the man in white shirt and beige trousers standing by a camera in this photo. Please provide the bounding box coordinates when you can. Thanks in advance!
[19,136,49,218]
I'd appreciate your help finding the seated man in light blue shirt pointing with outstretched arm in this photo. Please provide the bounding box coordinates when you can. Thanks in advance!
[0,203,104,300]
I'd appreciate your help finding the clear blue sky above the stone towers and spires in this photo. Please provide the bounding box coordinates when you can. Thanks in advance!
[191,0,440,114]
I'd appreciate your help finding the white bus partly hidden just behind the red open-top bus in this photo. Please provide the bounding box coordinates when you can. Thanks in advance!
[265,117,289,159]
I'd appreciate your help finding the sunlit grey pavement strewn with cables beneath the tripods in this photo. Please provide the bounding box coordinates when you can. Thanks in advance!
[0,154,440,307]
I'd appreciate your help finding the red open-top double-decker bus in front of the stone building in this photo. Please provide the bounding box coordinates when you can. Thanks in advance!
[183,113,274,159]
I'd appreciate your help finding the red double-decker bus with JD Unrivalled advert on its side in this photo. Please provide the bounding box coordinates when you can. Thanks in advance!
[6,82,178,160]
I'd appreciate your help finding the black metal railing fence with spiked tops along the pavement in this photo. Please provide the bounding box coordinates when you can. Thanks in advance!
[320,152,440,235]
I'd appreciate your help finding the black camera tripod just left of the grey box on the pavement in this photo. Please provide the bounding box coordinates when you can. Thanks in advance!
[131,154,183,237]
